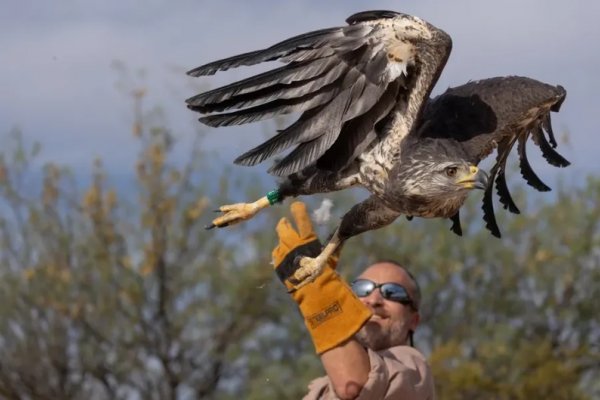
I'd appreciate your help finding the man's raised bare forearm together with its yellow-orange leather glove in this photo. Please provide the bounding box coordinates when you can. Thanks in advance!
[273,202,371,399]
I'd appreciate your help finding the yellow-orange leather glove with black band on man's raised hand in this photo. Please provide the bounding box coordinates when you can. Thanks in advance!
[273,201,371,354]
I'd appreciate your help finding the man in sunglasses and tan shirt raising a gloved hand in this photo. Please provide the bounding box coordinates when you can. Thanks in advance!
[273,202,434,400]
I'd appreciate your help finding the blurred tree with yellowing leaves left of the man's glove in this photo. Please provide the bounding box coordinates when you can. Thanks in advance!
[0,90,318,399]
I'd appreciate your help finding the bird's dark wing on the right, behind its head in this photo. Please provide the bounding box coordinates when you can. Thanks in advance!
[419,76,569,237]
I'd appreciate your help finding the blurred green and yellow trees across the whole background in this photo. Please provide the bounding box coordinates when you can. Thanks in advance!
[0,86,600,399]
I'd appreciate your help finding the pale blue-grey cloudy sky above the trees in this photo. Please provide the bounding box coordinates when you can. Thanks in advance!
[0,0,600,183]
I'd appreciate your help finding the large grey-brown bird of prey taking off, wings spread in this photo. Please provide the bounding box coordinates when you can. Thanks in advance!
[187,11,569,287]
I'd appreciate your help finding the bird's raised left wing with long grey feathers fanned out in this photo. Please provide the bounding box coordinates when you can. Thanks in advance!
[187,11,450,176]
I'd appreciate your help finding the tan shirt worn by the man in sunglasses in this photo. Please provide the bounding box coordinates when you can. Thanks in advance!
[304,346,435,400]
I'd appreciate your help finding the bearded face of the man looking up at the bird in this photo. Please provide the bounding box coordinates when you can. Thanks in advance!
[356,263,419,350]
